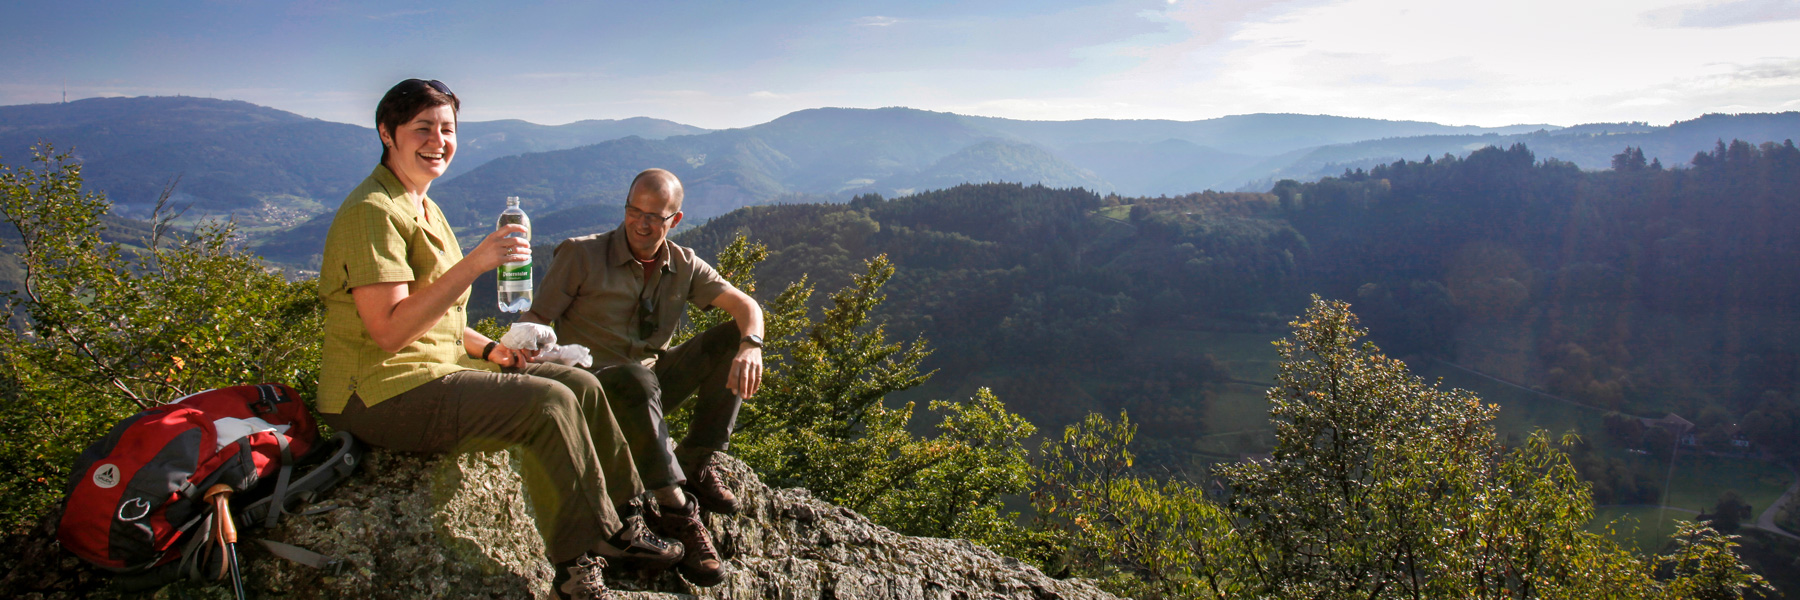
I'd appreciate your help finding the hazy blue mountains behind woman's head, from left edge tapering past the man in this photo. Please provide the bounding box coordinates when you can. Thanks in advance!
[0,95,707,227]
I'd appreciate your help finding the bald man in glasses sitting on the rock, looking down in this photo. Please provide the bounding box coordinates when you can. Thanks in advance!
[520,169,763,586]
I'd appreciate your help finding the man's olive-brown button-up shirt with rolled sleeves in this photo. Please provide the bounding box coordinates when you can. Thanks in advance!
[520,223,731,366]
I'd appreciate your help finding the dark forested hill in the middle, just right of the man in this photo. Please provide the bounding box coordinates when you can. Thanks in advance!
[680,184,1309,436]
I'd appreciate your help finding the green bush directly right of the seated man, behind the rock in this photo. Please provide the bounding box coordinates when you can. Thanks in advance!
[675,236,1044,557]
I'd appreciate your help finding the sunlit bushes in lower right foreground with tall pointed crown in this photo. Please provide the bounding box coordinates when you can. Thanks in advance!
[1033,297,1771,598]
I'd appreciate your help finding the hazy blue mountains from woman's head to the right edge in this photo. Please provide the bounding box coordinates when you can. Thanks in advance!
[432,108,1800,225]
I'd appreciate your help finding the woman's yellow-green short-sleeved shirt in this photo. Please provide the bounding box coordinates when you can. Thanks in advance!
[319,166,497,413]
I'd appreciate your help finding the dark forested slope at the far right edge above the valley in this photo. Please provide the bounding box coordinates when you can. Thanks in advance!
[1276,141,1800,452]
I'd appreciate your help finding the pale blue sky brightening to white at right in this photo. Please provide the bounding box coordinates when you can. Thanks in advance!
[0,0,1800,128]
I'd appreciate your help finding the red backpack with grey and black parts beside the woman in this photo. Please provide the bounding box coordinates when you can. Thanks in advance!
[56,384,320,573]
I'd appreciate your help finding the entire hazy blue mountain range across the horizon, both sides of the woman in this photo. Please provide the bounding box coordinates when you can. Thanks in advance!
[0,97,1800,263]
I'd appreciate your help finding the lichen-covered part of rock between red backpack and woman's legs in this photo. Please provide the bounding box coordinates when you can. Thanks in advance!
[247,450,551,598]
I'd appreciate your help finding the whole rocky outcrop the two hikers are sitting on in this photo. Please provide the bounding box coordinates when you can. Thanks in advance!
[247,446,1112,600]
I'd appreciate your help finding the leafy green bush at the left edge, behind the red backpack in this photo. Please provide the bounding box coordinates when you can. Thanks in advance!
[0,148,322,530]
